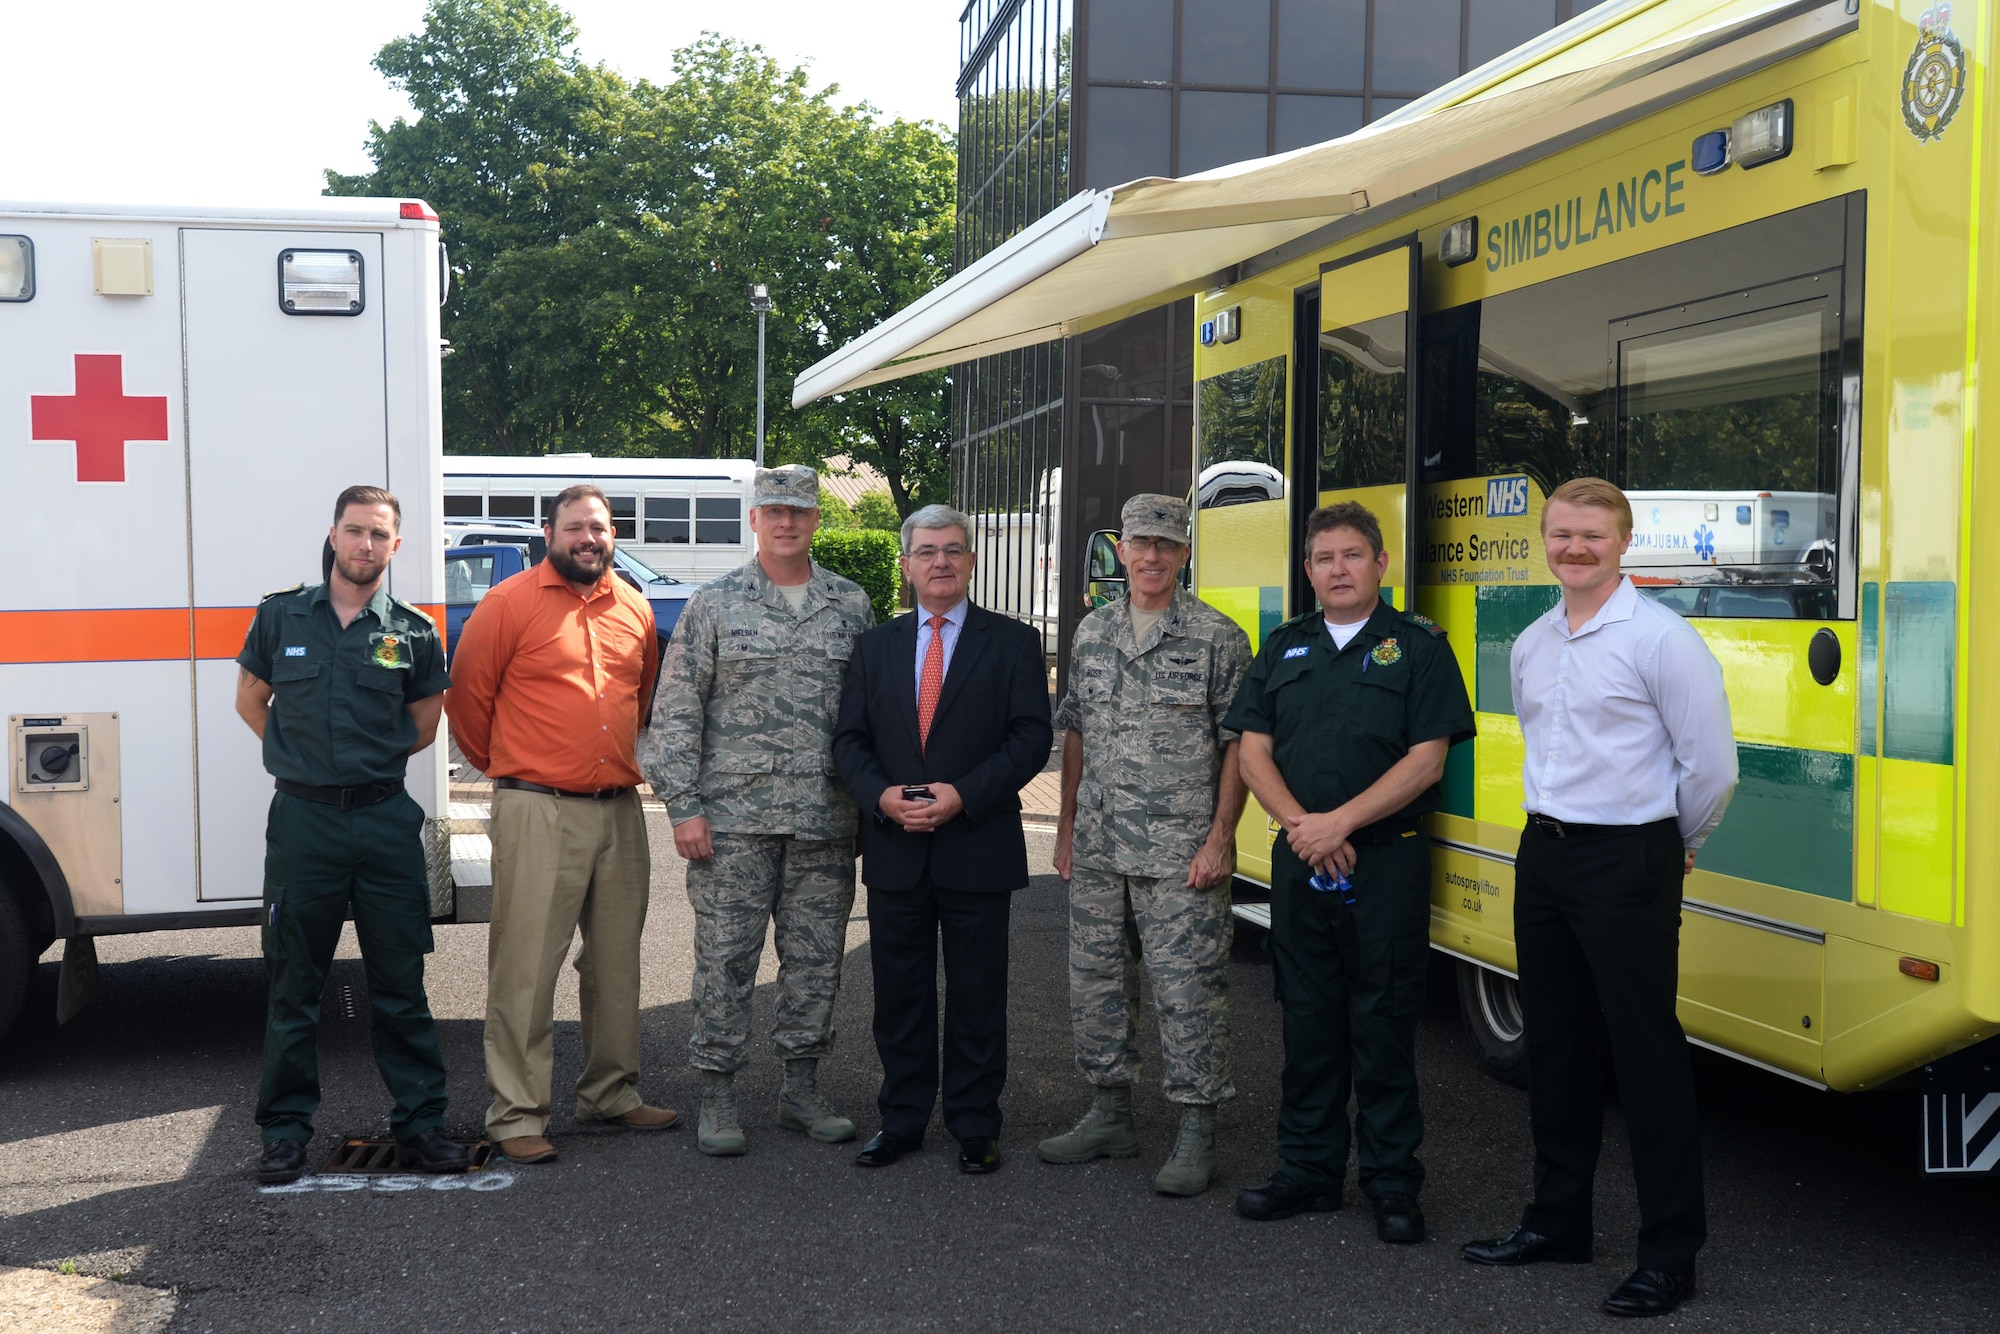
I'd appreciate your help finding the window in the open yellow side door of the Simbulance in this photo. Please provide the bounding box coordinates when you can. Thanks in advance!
[1320,312,1408,490]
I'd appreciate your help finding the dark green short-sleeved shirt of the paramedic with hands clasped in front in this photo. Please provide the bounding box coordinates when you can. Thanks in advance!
[1222,602,1472,828]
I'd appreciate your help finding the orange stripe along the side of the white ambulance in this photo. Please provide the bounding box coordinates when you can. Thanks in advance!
[0,606,444,664]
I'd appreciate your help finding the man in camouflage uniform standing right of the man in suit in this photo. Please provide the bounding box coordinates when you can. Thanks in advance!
[1036,496,1250,1196]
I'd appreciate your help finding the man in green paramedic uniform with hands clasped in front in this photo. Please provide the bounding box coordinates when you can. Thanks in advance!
[1222,502,1472,1242]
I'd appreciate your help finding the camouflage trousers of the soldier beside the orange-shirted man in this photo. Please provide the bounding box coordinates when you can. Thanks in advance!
[688,834,854,1072]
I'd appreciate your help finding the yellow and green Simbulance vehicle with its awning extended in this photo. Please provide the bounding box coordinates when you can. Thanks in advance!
[794,0,2000,1172]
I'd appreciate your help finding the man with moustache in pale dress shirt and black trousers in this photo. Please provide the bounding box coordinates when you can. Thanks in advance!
[1464,478,1736,1316]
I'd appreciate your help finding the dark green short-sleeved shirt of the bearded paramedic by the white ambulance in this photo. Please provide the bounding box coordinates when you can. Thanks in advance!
[236,584,452,788]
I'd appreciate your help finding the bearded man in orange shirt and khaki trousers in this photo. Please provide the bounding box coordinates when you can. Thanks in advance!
[446,486,678,1162]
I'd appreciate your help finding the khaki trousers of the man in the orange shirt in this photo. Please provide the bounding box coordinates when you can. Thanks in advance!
[486,788,652,1140]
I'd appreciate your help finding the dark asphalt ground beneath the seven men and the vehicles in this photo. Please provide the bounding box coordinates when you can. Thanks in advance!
[0,812,2000,1334]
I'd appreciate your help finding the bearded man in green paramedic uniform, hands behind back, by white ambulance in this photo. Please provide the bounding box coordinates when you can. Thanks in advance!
[236,486,468,1182]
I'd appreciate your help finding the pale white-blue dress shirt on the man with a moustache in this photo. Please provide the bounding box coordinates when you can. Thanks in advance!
[1512,578,1736,848]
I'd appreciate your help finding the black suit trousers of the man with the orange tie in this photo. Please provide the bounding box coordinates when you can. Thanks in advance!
[868,876,1014,1140]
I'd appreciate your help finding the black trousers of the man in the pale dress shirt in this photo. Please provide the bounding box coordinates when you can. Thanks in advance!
[1514,820,1708,1274]
